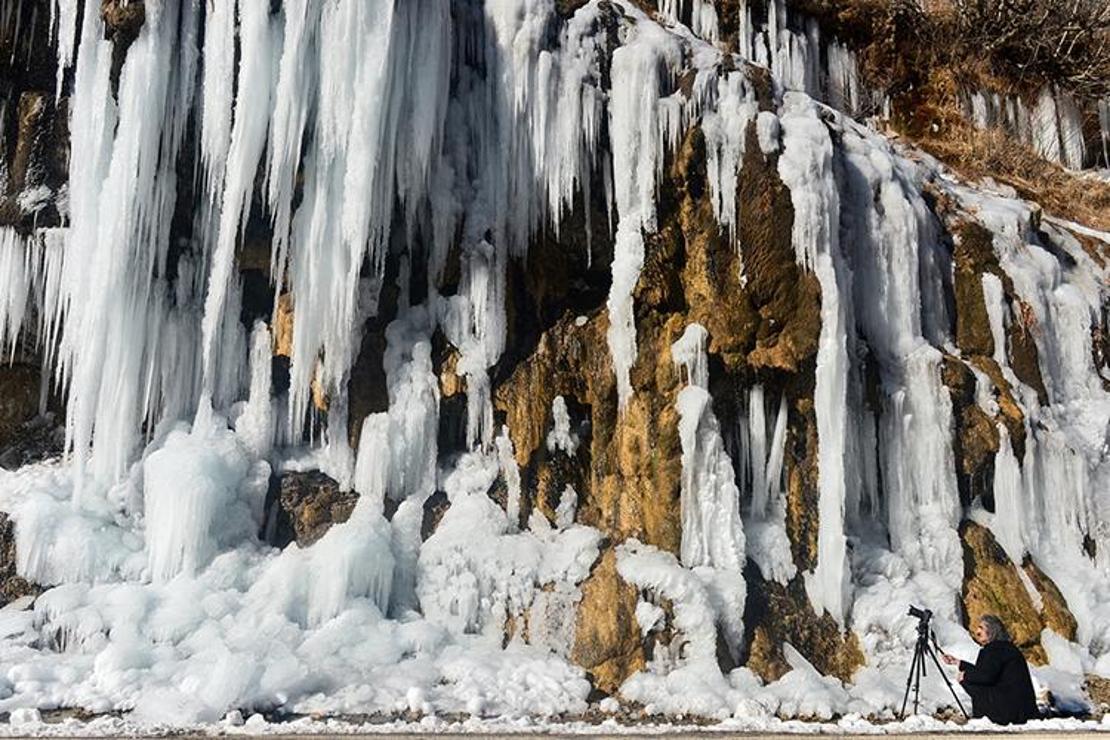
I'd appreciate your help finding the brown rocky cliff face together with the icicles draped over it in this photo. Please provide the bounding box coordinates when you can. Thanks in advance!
[0,0,1110,717]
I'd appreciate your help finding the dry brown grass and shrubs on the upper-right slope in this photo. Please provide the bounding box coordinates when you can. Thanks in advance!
[790,0,1110,230]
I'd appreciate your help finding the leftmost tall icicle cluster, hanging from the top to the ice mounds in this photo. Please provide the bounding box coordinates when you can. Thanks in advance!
[59,0,198,505]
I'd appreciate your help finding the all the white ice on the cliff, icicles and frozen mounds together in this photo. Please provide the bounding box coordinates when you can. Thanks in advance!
[0,0,1110,721]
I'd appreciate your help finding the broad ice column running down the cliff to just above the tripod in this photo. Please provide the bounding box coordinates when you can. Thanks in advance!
[839,128,962,588]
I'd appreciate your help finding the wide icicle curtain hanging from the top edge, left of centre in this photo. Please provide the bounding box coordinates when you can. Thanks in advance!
[286,0,451,428]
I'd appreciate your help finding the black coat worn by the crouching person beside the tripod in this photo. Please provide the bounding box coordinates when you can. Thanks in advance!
[960,640,1037,724]
